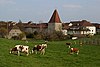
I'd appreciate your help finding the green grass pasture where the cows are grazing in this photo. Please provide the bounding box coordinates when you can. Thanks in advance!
[0,38,100,67]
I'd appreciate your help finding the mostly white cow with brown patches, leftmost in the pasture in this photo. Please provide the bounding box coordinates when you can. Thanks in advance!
[10,45,29,56]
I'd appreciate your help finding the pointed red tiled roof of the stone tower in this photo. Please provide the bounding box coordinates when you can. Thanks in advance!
[49,9,61,23]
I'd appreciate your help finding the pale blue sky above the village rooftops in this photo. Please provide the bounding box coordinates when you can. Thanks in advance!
[0,0,100,23]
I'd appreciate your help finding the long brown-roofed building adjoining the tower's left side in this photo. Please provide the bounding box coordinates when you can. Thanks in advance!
[17,22,48,33]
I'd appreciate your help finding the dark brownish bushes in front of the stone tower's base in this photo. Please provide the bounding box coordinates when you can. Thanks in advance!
[26,31,70,41]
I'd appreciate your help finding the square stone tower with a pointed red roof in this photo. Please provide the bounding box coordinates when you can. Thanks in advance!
[48,9,62,32]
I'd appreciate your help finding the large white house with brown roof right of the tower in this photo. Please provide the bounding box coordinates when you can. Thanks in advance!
[67,20,96,35]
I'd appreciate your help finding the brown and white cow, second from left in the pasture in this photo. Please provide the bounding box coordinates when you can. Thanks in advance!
[32,44,47,55]
